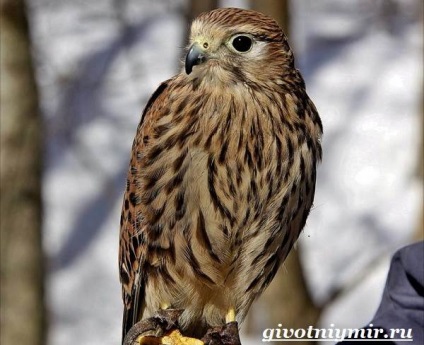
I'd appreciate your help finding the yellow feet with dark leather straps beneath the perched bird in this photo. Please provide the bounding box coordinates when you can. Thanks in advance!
[123,309,241,345]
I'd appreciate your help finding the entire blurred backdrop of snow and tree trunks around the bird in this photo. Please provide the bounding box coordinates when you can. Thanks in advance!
[0,0,423,345]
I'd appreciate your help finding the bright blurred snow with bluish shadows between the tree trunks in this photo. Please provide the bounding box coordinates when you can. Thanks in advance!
[29,0,423,345]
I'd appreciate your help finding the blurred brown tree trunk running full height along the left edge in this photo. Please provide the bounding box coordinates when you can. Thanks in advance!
[0,0,45,345]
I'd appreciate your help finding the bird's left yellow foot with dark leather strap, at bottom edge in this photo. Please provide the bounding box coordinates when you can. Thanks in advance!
[123,309,203,345]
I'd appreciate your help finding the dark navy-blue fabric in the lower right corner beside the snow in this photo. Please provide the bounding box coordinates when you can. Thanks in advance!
[338,242,424,345]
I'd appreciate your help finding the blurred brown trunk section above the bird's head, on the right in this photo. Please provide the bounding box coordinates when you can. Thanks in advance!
[250,0,290,36]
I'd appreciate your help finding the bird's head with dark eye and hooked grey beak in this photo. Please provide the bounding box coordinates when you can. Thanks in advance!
[185,8,293,84]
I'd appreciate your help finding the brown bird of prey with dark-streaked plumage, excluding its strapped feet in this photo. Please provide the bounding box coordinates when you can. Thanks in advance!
[119,8,323,344]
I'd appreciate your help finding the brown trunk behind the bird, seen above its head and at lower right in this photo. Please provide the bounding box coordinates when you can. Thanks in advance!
[243,0,321,344]
